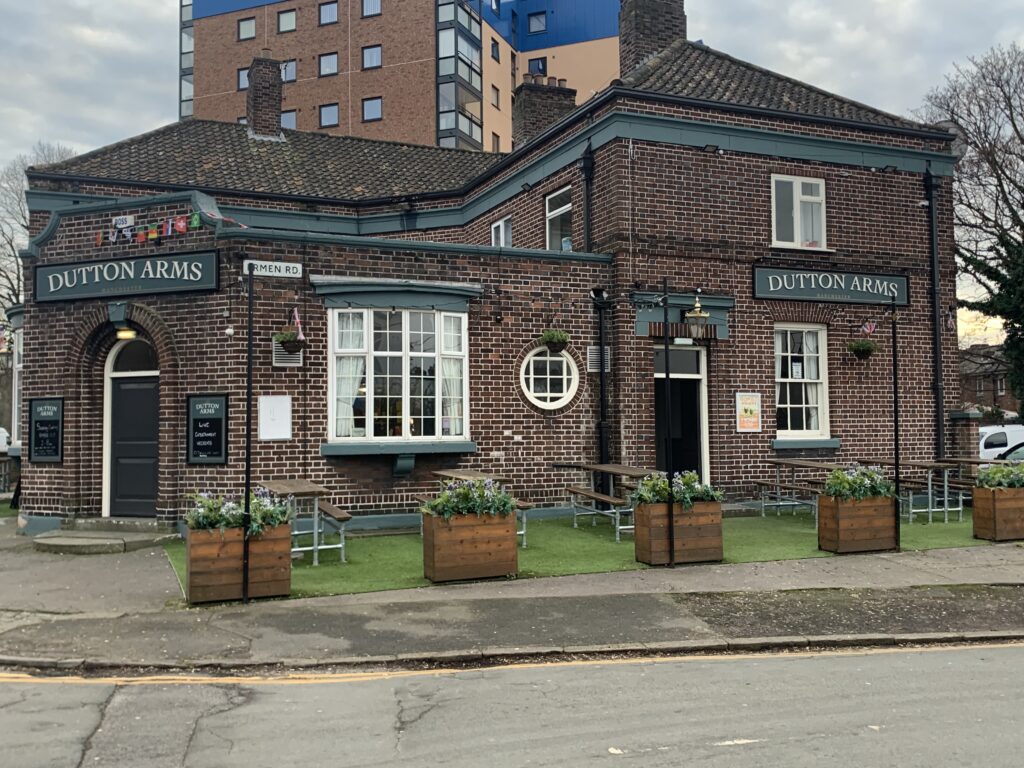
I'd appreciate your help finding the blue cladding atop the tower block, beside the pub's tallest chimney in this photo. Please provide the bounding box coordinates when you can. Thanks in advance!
[481,0,620,52]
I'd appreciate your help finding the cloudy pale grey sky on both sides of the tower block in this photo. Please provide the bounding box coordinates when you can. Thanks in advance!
[0,0,1024,335]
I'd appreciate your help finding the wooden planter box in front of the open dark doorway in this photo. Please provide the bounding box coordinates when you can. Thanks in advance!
[633,502,722,565]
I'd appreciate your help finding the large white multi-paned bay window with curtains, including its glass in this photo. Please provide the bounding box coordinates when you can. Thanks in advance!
[330,308,469,441]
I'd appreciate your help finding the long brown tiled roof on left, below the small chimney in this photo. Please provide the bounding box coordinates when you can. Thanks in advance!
[29,120,503,201]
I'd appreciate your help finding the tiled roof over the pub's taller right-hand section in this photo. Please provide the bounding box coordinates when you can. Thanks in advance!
[623,40,926,129]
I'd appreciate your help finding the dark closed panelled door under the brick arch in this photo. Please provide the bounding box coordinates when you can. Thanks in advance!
[110,376,160,517]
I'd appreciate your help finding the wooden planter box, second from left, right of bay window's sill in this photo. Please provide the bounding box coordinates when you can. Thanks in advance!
[423,513,519,582]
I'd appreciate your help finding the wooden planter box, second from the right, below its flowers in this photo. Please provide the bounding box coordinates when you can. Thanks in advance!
[818,496,897,554]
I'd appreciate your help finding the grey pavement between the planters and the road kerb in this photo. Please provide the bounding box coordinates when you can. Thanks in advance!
[6,520,1024,668]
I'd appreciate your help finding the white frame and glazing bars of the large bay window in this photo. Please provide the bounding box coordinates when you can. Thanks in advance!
[327,307,470,445]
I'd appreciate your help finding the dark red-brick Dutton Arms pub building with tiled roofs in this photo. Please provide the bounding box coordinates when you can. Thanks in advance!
[19,0,961,524]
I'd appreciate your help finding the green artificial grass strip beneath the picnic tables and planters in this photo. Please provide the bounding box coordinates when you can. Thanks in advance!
[165,512,987,597]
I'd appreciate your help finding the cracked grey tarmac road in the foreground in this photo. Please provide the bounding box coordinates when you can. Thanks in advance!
[0,645,1024,768]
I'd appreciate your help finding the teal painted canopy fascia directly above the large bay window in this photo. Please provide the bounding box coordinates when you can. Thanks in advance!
[313,279,483,312]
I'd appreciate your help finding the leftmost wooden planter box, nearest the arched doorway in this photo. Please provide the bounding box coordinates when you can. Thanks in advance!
[185,523,292,605]
